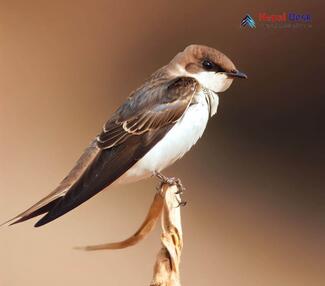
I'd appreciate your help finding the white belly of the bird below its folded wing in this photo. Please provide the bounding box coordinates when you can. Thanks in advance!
[116,94,216,183]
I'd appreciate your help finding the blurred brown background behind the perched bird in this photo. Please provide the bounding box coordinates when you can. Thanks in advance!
[0,0,325,286]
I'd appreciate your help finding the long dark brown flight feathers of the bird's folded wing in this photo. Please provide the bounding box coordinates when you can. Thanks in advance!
[35,125,172,227]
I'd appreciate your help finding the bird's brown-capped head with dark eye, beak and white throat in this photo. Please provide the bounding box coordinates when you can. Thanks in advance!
[170,45,247,93]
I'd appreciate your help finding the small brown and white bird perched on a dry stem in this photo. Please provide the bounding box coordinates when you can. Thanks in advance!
[4,44,247,227]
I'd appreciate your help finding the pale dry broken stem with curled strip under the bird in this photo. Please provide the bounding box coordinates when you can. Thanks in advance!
[78,183,183,286]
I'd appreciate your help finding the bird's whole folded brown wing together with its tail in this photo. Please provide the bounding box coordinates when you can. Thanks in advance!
[5,73,198,227]
